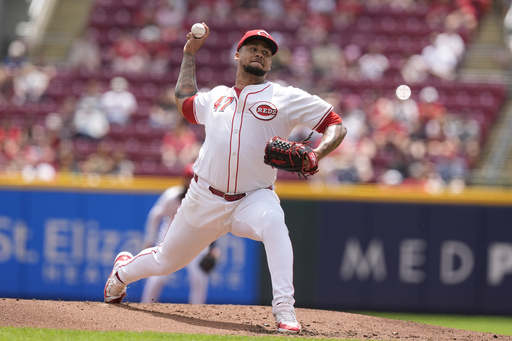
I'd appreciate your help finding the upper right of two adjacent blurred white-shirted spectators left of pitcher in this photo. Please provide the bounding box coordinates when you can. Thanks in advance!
[100,77,138,125]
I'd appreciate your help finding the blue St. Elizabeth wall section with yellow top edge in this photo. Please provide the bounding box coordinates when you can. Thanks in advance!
[0,175,260,304]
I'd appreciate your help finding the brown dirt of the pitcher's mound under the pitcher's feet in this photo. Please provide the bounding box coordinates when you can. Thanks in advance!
[0,298,512,341]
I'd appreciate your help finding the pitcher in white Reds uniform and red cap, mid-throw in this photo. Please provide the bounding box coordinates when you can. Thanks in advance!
[104,25,347,332]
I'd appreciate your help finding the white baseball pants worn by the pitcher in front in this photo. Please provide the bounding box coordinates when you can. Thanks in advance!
[118,179,294,306]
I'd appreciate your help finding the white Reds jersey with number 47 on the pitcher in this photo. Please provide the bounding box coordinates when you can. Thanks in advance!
[184,82,333,193]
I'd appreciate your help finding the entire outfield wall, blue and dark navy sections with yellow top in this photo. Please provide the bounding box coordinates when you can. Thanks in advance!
[0,178,512,314]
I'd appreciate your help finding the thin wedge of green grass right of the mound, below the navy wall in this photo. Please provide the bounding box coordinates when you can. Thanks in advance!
[354,312,512,336]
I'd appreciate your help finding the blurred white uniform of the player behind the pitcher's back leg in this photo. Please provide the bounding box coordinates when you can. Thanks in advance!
[141,185,209,304]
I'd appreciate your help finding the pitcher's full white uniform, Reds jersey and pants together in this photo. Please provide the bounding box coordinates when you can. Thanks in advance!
[117,82,332,306]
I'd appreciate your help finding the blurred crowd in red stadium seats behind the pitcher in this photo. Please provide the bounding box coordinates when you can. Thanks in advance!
[0,0,504,191]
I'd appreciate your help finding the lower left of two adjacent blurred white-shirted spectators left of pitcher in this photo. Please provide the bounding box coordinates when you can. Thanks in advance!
[73,100,110,140]
